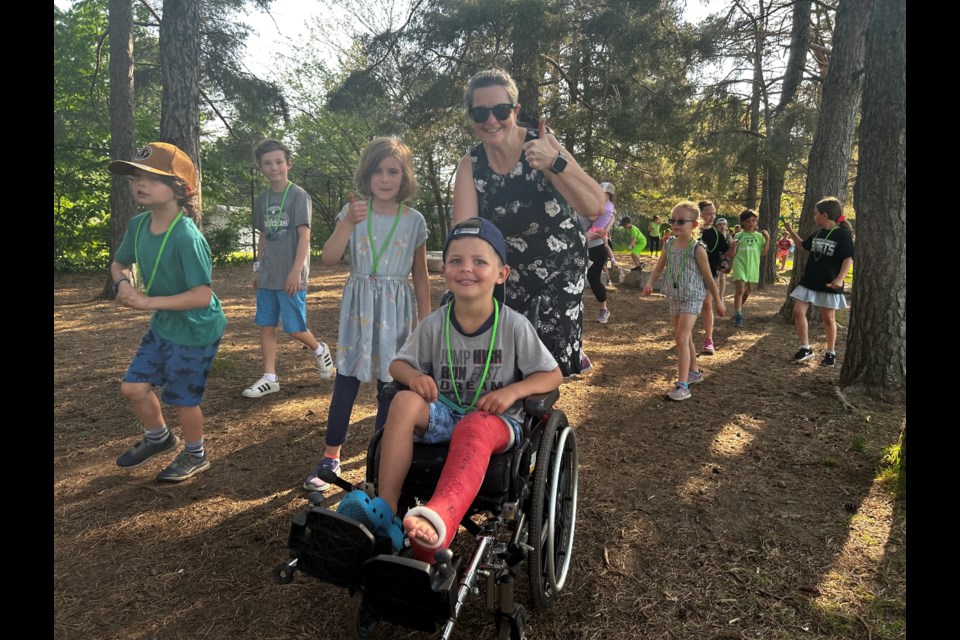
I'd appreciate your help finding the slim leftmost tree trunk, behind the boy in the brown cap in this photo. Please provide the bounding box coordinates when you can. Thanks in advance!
[102,0,137,300]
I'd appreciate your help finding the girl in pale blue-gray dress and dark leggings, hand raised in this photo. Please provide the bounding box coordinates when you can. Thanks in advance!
[303,138,430,491]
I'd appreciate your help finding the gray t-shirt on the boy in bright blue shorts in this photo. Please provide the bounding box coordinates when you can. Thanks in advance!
[253,182,313,289]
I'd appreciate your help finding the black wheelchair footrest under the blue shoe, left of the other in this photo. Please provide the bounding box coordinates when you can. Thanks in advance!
[288,507,390,587]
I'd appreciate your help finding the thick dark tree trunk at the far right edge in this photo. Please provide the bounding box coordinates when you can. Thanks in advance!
[840,0,907,400]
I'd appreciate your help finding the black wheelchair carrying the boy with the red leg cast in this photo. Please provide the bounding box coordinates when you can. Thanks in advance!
[274,385,579,640]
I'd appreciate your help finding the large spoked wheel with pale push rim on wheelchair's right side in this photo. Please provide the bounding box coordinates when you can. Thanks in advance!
[527,411,579,611]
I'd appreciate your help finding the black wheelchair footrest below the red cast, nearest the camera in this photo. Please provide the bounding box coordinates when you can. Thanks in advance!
[363,555,457,633]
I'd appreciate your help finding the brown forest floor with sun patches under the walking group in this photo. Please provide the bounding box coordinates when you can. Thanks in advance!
[53,266,906,640]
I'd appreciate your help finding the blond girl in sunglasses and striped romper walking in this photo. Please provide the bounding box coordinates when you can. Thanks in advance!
[643,200,726,401]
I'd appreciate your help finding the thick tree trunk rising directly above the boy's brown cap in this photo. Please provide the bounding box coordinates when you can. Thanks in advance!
[160,0,202,226]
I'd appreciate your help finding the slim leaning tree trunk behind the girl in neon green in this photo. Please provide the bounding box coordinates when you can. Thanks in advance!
[757,0,811,289]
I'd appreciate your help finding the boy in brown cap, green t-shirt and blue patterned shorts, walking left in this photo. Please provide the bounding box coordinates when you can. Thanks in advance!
[109,142,227,482]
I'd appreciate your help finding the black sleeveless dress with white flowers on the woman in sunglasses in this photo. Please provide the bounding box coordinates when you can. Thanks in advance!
[470,129,587,376]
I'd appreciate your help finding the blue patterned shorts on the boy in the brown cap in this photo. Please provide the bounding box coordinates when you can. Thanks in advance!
[123,329,220,407]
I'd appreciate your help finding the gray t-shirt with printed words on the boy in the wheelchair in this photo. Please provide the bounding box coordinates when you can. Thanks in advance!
[396,305,557,422]
